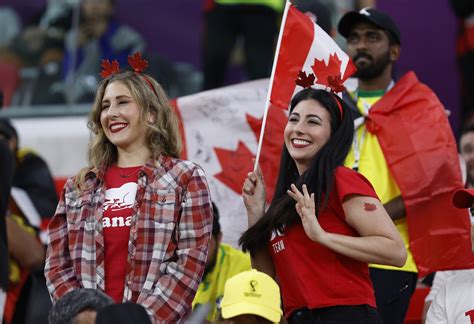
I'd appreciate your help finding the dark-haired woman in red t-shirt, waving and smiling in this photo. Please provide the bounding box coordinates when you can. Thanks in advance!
[240,88,406,323]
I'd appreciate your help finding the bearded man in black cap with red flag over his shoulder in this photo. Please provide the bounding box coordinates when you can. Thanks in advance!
[338,8,468,324]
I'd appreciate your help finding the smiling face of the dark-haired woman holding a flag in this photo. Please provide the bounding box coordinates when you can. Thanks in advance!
[284,99,331,174]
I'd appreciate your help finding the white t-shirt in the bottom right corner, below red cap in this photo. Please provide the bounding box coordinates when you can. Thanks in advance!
[426,269,474,324]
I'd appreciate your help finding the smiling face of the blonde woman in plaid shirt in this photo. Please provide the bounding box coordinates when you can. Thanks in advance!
[100,81,147,153]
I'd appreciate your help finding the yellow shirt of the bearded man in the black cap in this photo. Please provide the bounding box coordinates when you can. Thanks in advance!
[344,91,418,272]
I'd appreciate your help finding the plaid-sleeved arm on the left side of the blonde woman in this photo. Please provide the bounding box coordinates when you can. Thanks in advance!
[44,179,81,300]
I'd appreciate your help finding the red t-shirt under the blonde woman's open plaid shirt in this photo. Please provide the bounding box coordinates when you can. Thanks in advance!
[102,165,141,303]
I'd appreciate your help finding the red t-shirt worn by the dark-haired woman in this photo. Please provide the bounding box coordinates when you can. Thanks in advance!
[269,167,377,317]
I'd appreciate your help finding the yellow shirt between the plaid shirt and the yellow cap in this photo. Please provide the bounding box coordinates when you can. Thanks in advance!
[193,243,252,322]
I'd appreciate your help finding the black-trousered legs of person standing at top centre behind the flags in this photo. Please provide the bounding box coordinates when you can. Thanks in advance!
[202,0,284,90]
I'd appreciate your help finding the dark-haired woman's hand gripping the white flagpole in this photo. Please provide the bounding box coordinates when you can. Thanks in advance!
[242,166,266,227]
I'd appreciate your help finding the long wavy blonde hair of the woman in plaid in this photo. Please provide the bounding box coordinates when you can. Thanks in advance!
[76,71,181,189]
